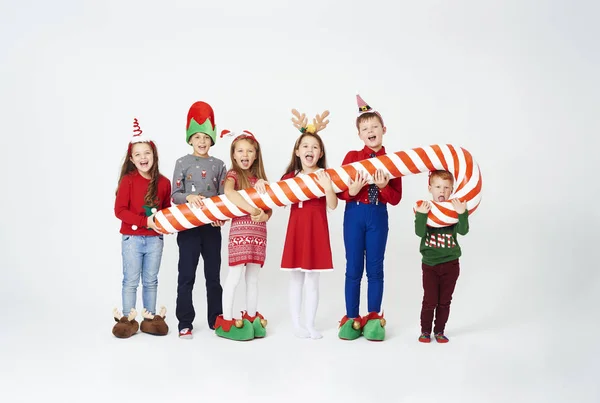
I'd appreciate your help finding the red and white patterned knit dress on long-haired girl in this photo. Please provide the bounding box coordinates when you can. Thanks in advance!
[227,170,267,267]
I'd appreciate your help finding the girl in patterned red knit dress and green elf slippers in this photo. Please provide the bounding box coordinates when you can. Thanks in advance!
[215,131,272,341]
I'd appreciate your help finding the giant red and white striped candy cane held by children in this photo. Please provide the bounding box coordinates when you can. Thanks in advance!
[154,144,481,234]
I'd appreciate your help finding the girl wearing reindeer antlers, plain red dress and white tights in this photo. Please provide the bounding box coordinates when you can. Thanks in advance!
[281,110,338,339]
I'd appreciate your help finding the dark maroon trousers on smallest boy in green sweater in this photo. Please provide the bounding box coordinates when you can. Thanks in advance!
[421,259,460,333]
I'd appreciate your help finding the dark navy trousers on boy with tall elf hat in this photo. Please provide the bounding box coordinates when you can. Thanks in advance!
[175,224,223,330]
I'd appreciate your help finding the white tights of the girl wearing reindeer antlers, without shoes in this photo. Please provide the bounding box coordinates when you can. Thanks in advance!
[290,271,323,339]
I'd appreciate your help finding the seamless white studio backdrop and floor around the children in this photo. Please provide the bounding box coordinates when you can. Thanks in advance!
[0,0,600,402]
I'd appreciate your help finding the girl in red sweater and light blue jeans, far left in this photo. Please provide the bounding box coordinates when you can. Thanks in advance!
[115,119,171,333]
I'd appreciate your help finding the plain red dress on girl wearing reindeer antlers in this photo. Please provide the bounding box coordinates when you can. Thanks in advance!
[281,172,333,271]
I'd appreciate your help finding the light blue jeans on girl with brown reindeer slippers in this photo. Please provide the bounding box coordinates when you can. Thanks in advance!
[121,235,164,316]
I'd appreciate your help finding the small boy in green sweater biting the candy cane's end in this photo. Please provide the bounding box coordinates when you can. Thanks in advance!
[415,170,469,343]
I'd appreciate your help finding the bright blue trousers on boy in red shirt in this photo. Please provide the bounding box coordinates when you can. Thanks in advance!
[344,202,389,318]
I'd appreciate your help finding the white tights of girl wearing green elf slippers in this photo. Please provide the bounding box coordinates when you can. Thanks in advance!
[223,263,260,320]
